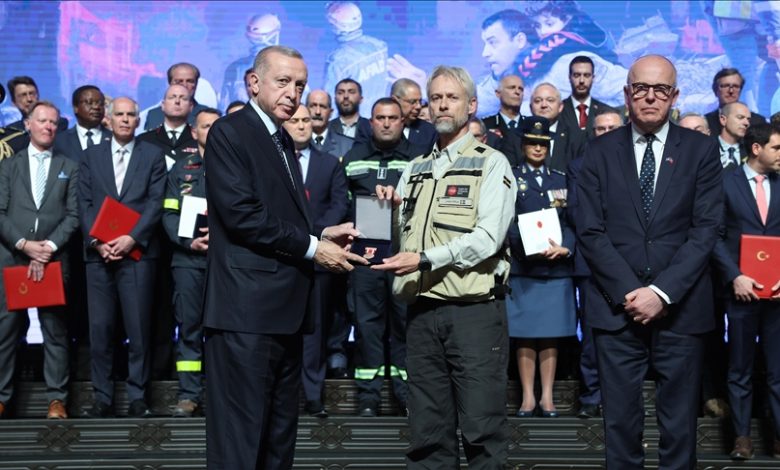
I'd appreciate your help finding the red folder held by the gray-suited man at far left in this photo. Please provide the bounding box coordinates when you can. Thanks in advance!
[3,261,65,310]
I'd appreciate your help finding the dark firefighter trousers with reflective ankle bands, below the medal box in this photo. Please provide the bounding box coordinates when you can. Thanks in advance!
[349,266,408,408]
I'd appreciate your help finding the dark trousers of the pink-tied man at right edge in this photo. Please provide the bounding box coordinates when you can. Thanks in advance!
[728,300,780,439]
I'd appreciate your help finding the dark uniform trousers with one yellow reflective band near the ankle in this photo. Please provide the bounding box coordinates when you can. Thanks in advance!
[172,267,206,403]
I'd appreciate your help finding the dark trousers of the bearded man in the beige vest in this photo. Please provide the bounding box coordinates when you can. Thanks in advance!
[406,298,509,470]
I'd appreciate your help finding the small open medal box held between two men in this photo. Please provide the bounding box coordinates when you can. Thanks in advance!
[352,196,393,264]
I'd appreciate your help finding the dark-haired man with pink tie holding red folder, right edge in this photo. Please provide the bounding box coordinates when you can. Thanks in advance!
[713,124,780,460]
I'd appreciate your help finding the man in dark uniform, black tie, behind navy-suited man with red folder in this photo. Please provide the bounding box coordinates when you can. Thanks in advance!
[138,85,198,170]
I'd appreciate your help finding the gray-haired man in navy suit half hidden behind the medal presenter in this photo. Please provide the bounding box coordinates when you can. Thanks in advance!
[283,106,349,418]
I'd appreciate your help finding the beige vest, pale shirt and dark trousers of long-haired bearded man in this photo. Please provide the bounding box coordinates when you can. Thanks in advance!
[393,133,517,469]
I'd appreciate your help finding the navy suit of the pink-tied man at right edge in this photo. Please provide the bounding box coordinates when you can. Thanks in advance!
[713,166,780,438]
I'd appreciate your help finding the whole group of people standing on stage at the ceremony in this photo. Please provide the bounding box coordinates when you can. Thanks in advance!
[0,29,780,469]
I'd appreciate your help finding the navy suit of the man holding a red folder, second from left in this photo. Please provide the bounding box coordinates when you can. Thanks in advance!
[79,140,165,405]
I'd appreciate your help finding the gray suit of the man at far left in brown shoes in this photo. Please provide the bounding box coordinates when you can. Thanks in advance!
[0,149,79,403]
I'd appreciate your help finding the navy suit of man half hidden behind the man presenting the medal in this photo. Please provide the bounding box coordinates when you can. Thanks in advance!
[302,147,349,401]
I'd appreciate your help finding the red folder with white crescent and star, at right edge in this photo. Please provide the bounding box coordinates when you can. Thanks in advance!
[739,235,780,299]
